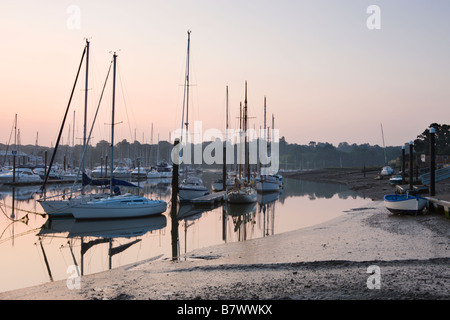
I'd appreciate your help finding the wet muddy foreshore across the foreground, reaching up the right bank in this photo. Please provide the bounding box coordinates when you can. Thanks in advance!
[0,170,450,301]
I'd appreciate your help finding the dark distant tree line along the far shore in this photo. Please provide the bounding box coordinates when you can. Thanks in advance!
[0,123,450,169]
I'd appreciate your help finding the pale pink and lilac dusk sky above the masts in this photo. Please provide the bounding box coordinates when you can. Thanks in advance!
[0,0,450,146]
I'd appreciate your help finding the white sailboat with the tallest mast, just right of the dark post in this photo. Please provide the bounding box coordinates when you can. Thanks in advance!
[178,30,209,201]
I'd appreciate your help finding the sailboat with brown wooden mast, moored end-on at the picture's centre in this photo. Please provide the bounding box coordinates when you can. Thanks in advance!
[227,81,257,203]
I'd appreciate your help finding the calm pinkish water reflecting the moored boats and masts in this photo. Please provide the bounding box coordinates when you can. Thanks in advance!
[0,172,370,292]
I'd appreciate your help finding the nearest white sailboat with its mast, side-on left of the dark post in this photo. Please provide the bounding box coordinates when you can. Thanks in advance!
[72,52,167,219]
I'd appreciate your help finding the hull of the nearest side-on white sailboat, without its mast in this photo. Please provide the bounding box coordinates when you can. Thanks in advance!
[72,195,167,219]
